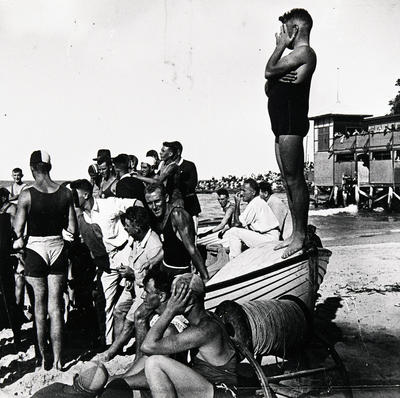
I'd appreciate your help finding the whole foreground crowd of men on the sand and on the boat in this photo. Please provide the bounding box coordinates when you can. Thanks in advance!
[0,9,320,397]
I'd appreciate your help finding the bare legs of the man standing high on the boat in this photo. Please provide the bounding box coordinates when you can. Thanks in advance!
[275,135,310,258]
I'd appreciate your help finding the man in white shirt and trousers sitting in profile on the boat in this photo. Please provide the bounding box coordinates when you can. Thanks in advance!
[226,178,279,259]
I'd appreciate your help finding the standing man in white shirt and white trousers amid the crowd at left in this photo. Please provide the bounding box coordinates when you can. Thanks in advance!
[71,180,143,345]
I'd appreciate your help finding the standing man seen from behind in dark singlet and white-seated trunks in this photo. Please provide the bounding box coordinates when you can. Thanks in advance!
[14,151,76,369]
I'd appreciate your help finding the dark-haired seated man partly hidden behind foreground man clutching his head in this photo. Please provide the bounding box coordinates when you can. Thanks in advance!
[102,269,187,398]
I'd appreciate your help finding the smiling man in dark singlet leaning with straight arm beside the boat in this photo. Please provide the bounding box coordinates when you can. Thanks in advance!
[145,184,208,280]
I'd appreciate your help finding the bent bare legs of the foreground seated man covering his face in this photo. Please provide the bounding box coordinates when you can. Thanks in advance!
[145,355,214,398]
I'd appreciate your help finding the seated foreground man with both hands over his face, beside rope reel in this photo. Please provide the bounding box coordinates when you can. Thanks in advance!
[142,274,237,398]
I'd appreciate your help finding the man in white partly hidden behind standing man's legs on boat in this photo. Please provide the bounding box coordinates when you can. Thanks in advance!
[259,181,292,240]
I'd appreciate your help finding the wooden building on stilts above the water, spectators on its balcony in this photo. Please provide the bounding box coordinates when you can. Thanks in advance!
[310,113,400,208]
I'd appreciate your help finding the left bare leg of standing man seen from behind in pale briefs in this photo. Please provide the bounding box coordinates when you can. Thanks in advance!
[25,276,47,369]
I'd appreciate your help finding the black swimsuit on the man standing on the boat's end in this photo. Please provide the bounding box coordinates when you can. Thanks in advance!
[268,78,311,142]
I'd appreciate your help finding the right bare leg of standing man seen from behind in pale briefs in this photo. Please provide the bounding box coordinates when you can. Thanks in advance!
[47,275,65,370]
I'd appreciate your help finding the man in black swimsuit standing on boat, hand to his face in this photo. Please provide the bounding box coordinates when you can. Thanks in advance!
[265,8,317,258]
